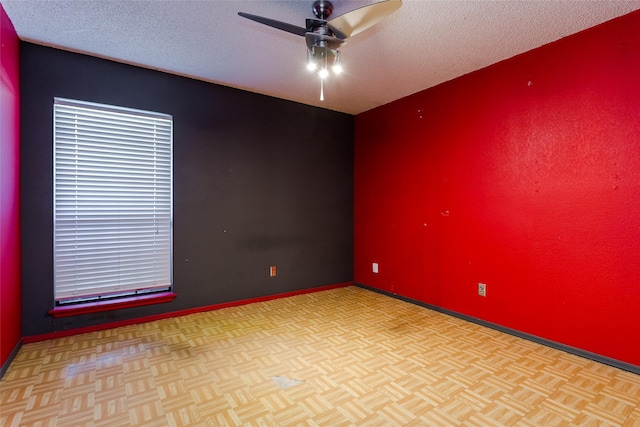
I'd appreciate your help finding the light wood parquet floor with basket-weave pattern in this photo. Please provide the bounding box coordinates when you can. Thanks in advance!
[0,287,640,427]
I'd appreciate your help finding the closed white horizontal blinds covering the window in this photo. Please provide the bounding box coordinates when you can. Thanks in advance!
[54,98,173,303]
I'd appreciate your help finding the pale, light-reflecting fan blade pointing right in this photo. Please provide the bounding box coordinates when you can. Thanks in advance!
[328,0,402,40]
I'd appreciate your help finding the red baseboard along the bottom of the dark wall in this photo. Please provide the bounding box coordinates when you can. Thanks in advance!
[22,282,353,344]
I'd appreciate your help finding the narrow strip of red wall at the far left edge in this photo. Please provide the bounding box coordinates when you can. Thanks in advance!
[0,5,21,367]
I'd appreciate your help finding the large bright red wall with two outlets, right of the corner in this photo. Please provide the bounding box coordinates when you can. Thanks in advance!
[354,12,640,365]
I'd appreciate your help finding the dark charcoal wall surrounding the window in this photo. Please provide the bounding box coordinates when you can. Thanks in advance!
[21,43,354,336]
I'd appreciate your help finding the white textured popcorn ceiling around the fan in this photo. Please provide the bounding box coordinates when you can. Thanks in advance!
[0,0,640,114]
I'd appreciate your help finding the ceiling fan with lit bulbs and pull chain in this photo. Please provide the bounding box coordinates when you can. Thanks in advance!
[238,0,402,101]
